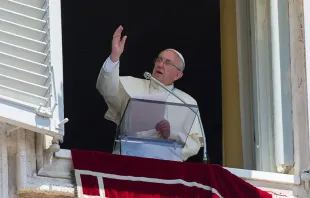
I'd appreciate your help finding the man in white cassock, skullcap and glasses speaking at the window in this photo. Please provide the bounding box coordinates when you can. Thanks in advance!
[96,26,202,161]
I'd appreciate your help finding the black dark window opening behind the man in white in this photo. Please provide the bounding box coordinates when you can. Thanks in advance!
[61,0,222,164]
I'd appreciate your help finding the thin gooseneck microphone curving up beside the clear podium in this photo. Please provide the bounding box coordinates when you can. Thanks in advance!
[143,72,208,163]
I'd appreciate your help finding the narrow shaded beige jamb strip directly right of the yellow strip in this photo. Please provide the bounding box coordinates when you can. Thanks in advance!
[236,0,256,169]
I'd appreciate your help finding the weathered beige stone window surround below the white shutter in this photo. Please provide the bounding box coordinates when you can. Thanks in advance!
[0,123,75,198]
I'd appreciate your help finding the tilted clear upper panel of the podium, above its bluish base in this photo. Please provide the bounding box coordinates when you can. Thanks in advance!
[117,98,198,145]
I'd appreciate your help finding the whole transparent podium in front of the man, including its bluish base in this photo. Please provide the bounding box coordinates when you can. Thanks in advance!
[114,98,199,161]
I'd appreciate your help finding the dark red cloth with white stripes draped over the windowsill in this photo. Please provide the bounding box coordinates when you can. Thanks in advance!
[71,150,272,198]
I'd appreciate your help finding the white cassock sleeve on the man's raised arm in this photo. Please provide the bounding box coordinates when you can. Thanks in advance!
[96,57,129,124]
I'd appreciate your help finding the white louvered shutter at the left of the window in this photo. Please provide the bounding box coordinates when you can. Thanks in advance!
[0,0,64,139]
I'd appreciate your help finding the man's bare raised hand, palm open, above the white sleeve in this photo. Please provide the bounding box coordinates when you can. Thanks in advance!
[111,26,127,62]
